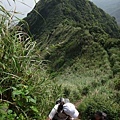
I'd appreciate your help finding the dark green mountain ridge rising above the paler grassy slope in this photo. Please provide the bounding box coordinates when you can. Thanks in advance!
[21,0,120,70]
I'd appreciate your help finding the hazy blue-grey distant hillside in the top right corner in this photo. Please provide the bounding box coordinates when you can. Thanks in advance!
[92,0,120,25]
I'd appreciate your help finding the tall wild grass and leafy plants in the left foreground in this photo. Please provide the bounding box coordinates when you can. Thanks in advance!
[0,6,61,120]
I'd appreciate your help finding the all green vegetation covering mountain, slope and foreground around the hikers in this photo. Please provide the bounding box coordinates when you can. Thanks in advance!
[0,0,120,120]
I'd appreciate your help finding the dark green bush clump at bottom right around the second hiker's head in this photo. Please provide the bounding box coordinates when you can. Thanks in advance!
[78,94,120,120]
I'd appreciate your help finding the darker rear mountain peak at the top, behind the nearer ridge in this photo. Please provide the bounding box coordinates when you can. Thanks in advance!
[25,0,118,37]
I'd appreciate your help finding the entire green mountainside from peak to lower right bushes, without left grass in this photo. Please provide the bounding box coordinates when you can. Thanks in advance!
[20,0,120,120]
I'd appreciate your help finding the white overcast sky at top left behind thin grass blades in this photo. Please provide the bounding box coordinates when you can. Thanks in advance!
[0,0,39,18]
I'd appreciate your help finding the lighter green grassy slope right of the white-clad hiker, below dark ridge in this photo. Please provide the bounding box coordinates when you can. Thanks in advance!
[56,39,120,120]
